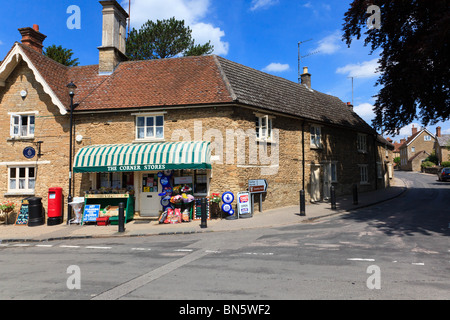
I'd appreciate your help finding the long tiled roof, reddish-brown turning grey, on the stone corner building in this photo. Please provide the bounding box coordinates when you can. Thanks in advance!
[10,43,376,134]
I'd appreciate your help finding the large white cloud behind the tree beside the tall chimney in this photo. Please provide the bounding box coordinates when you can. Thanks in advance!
[122,0,229,55]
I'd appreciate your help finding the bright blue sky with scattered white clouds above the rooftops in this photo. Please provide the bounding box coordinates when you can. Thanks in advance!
[0,0,450,140]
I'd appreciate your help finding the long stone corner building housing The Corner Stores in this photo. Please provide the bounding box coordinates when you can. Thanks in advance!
[0,1,393,221]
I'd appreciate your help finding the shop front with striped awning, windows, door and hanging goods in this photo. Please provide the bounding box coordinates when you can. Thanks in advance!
[74,142,212,223]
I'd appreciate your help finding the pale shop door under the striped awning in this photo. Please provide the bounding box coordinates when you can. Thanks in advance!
[140,173,162,218]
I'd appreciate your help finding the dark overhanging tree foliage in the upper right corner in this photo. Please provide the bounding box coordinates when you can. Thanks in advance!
[343,0,450,134]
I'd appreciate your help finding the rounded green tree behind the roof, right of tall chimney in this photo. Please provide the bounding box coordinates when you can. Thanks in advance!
[126,17,214,60]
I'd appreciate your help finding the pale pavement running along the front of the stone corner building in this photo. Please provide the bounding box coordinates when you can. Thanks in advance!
[0,178,407,244]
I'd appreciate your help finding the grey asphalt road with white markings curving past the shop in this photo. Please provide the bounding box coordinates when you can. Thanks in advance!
[0,172,450,301]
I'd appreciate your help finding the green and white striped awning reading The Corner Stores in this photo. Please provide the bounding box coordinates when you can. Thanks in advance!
[73,141,211,172]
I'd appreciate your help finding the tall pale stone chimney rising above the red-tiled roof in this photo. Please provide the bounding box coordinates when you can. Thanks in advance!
[98,0,128,75]
